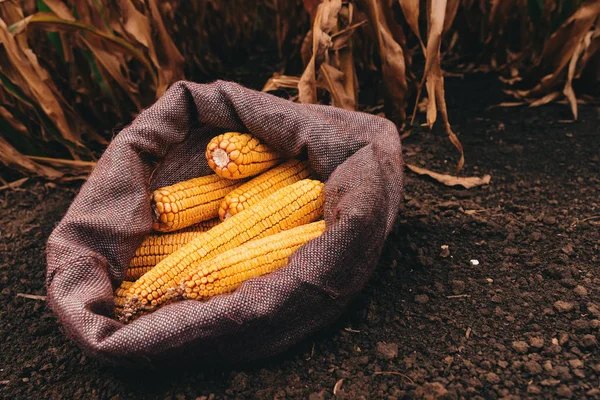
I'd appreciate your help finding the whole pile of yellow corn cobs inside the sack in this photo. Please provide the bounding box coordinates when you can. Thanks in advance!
[115,132,325,322]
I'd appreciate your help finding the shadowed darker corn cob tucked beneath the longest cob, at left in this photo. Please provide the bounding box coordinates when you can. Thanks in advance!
[124,218,221,281]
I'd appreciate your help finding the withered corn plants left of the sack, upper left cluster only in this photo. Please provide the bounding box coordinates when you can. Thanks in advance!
[0,0,274,180]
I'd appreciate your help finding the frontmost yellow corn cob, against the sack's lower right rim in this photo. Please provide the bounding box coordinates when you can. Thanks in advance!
[180,221,325,300]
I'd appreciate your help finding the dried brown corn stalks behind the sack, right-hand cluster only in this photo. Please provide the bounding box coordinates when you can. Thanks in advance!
[263,0,600,172]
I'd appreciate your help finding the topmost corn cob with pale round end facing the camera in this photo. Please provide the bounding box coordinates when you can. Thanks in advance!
[206,132,281,179]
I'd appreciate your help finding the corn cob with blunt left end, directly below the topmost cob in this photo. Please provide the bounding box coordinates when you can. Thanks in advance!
[152,175,244,232]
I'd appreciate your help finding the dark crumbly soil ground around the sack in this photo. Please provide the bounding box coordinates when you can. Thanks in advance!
[0,76,600,400]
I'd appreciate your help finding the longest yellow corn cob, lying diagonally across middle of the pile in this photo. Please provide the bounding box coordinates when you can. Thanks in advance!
[122,179,325,321]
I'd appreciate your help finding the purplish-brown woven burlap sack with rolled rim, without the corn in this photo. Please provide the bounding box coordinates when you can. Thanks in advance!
[46,81,403,365]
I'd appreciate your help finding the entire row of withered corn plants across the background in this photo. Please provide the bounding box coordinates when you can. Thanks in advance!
[0,0,600,180]
